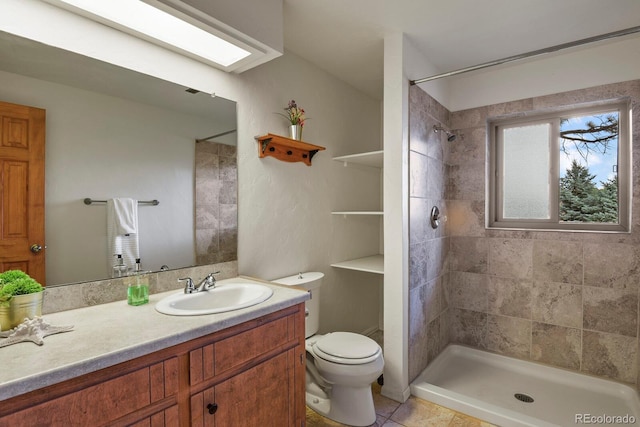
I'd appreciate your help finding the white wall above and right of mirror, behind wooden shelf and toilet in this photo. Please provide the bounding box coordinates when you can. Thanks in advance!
[0,0,381,332]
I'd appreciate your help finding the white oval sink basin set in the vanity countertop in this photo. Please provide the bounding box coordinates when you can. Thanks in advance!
[156,283,273,316]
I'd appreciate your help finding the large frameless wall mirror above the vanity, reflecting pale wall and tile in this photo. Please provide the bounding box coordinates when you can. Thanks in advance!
[0,32,237,286]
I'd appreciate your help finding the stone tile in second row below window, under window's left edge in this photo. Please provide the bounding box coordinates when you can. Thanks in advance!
[487,276,532,319]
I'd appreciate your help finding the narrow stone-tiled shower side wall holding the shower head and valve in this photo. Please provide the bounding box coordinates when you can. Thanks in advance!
[409,86,451,380]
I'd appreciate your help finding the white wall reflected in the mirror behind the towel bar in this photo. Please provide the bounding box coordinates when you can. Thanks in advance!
[0,72,222,285]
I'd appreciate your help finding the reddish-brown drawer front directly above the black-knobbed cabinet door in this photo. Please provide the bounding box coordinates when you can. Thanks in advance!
[189,316,296,385]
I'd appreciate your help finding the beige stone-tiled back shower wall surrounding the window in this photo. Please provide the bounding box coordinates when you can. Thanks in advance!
[444,81,640,385]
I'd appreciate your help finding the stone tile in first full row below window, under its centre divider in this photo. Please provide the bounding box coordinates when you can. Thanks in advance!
[533,240,582,285]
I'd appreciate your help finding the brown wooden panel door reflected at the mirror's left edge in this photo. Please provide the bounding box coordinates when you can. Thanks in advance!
[0,102,45,285]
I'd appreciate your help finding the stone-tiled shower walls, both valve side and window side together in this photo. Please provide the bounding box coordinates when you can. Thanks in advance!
[409,80,640,386]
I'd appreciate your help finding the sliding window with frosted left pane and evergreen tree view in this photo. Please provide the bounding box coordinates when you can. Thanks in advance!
[487,100,631,232]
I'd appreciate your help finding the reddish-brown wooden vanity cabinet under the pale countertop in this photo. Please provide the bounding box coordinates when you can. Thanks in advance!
[0,304,306,427]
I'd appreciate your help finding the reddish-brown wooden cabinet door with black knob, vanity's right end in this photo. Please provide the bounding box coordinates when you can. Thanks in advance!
[191,349,296,427]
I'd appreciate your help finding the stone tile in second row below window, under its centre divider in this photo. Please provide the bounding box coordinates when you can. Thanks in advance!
[531,281,582,328]
